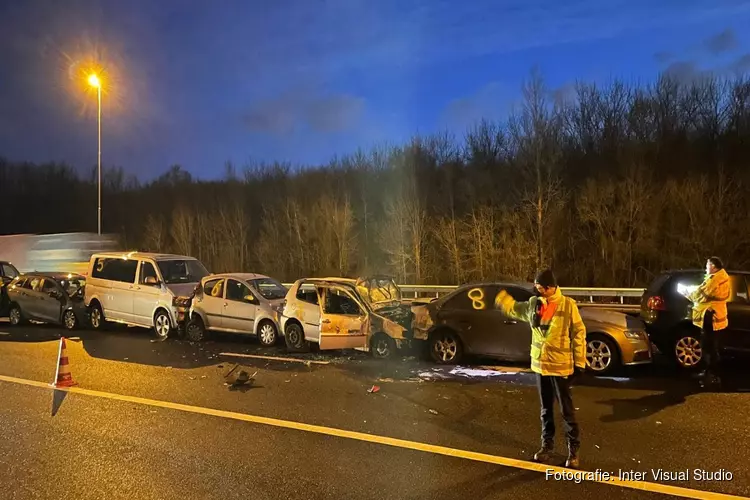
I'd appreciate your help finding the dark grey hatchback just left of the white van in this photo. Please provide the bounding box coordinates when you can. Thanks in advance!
[8,273,88,330]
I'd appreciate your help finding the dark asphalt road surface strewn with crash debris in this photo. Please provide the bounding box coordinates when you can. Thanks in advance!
[0,323,750,500]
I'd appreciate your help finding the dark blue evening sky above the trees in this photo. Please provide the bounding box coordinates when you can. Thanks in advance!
[0,0,750,179]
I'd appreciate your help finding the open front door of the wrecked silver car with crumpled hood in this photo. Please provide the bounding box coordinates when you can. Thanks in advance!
[319,287,369,350]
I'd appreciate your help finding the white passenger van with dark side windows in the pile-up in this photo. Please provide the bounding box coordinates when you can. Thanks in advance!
[84,252,209,338]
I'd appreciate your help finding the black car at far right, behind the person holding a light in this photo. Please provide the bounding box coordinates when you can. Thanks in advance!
[641,269,750,369]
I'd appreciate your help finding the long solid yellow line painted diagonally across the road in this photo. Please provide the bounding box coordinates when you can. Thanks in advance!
[0,375,748,500]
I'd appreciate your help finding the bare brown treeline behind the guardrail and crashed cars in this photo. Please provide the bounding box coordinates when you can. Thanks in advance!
[0,75,750,286]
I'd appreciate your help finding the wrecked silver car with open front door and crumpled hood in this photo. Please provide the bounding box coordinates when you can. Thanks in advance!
[280,277,420,358]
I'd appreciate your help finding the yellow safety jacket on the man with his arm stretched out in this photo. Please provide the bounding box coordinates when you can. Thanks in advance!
[495,288,586,377]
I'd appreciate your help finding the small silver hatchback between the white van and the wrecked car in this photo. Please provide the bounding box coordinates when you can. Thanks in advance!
[186,273,287,346]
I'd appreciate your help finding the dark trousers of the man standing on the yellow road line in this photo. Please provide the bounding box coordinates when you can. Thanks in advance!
[536,373,581,450]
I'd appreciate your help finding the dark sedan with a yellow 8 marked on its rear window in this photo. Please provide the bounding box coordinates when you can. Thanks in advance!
[412,283,652,375]
